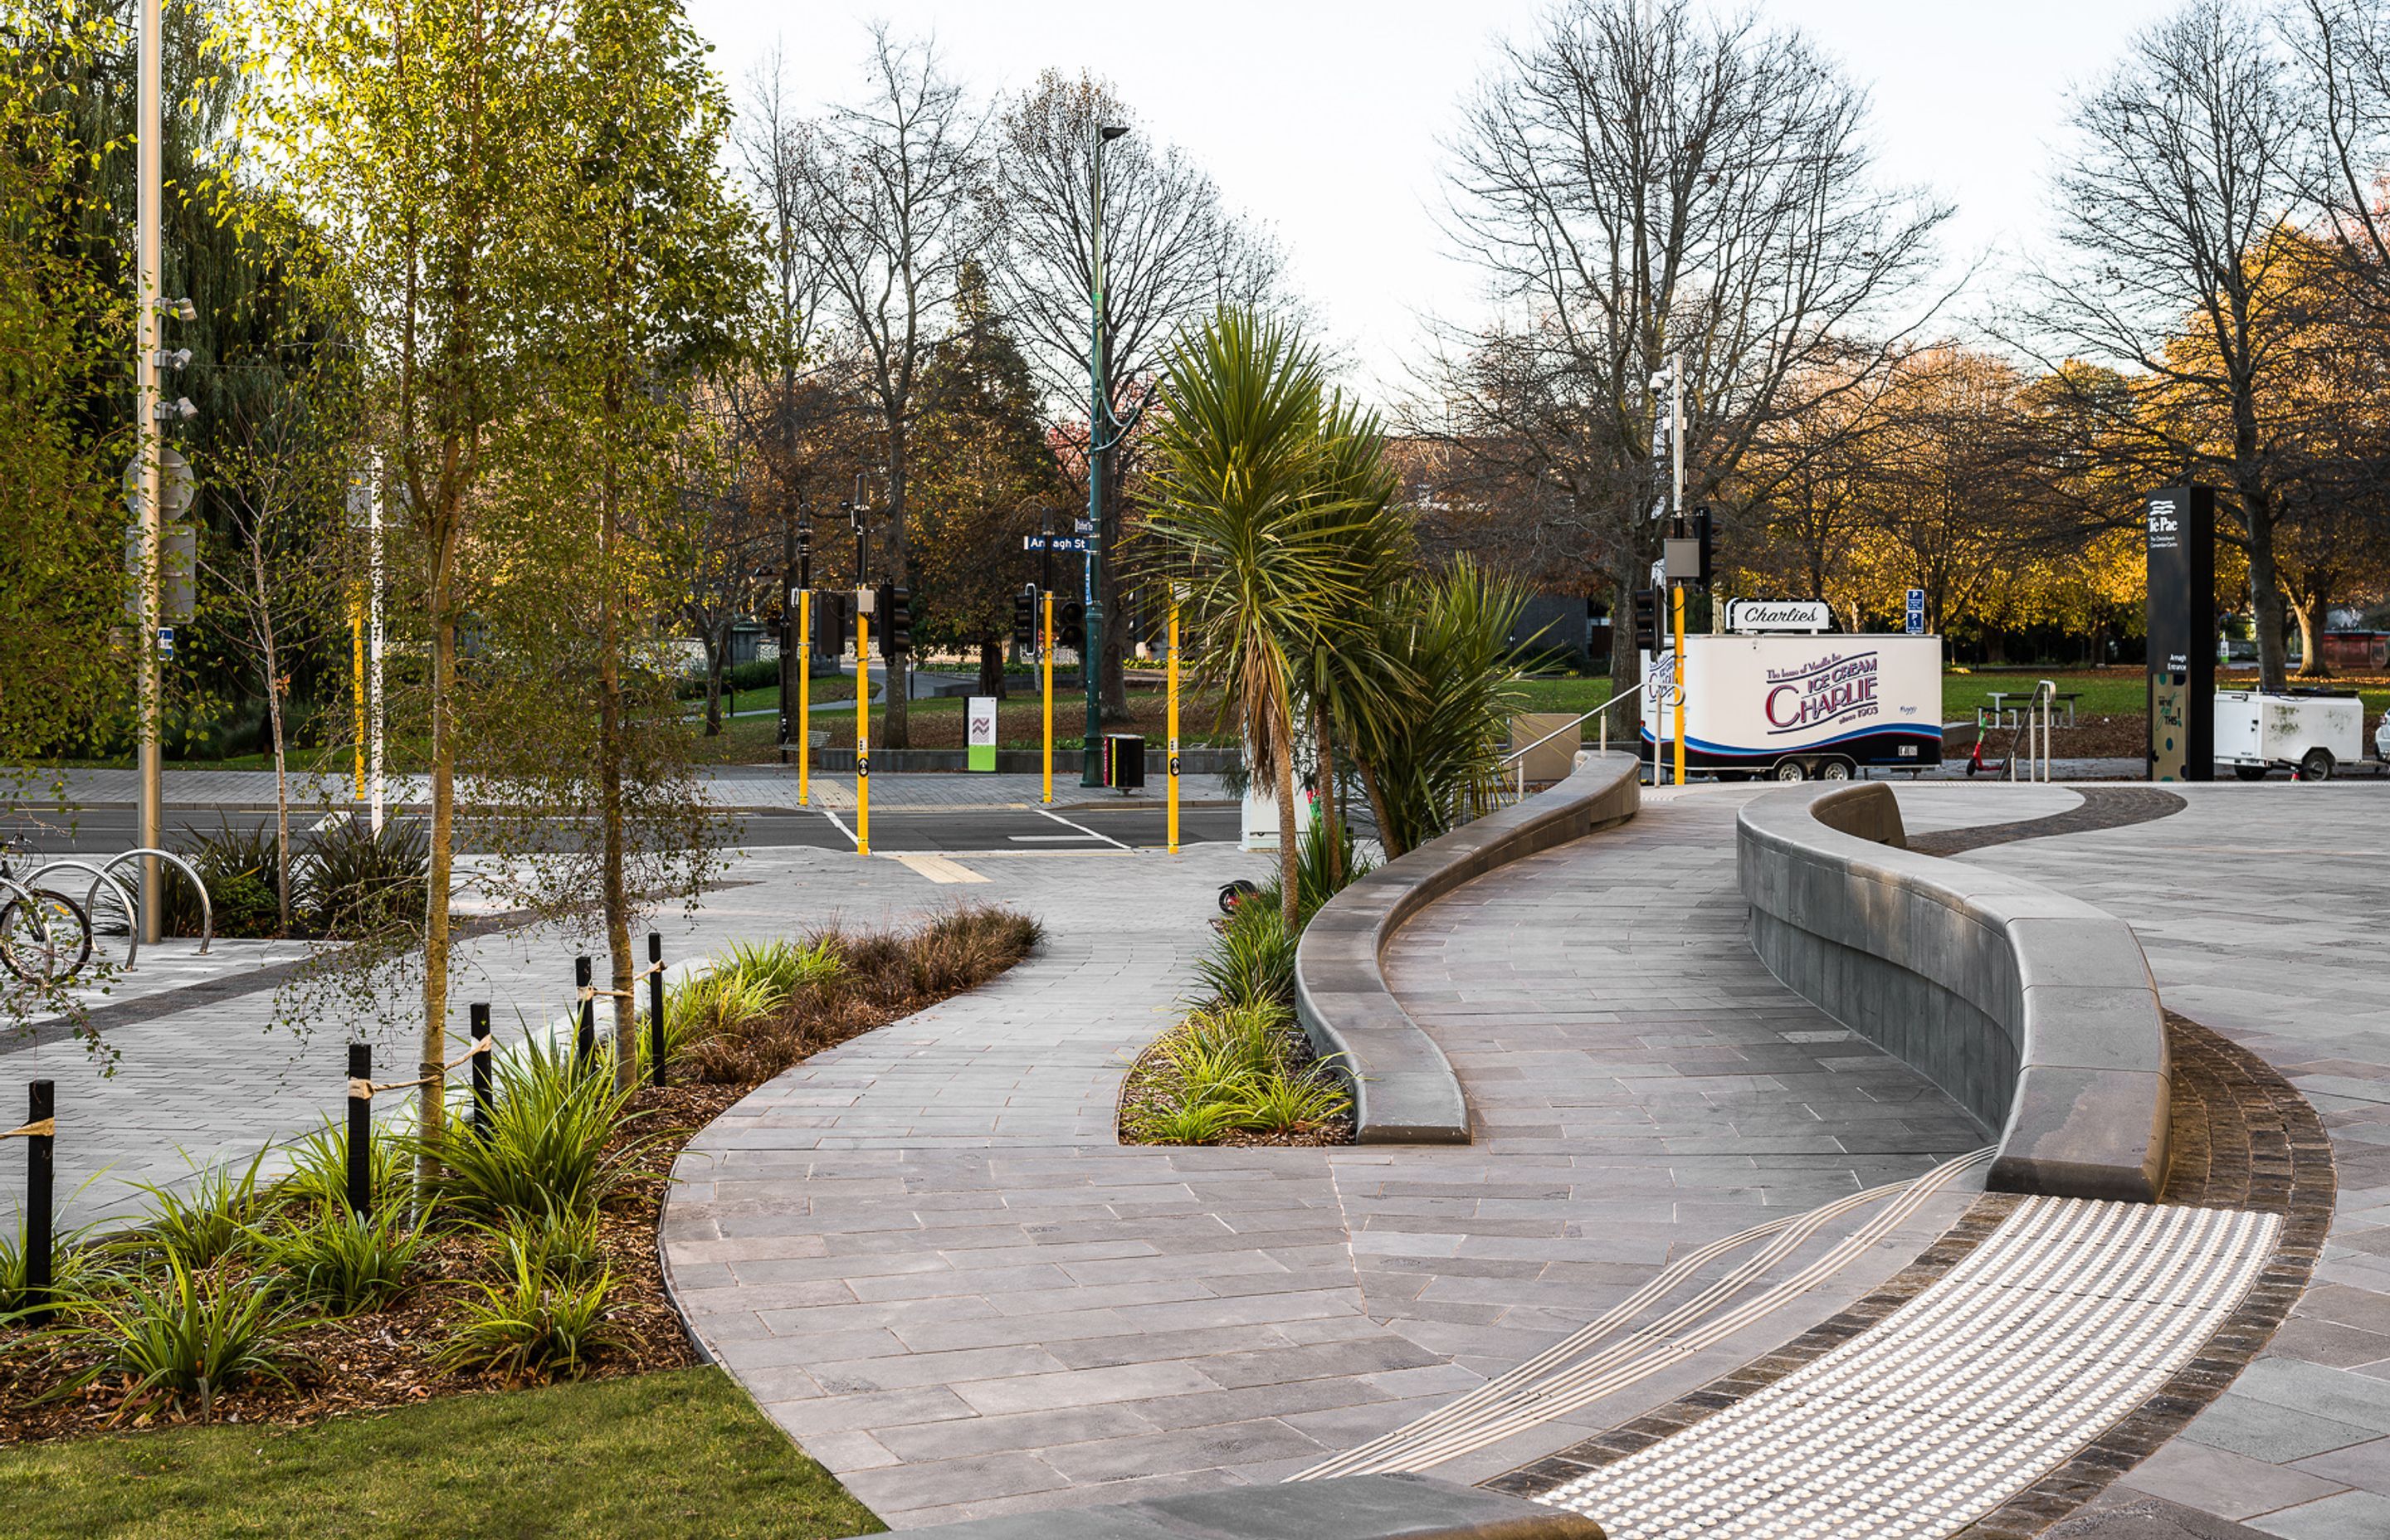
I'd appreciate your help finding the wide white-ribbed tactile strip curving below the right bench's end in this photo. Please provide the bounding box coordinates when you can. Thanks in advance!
[1539,1198,2280,1540]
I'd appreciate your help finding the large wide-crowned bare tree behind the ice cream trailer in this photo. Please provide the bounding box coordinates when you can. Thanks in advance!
[1429,0,1948,731]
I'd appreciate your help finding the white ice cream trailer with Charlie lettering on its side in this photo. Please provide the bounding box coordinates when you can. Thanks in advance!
[1642,636,1943,780]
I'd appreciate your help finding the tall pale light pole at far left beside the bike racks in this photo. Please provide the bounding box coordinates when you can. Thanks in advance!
[134,0,165,943]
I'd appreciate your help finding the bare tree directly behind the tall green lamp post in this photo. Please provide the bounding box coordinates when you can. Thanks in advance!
[992,70,1284,718]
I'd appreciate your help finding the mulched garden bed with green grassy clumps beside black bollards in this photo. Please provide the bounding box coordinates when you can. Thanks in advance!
[0,909,1040,1442]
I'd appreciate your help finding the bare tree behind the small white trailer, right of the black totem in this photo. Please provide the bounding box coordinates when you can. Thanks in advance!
[2017,0,2316,689]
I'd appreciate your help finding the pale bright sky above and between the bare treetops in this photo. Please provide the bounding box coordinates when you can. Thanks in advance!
[690,0,2170,387]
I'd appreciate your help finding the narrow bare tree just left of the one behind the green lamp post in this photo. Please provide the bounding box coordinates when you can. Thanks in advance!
[788,24,987,748]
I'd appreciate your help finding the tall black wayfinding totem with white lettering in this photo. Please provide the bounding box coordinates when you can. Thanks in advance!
[2141,485,2216,780]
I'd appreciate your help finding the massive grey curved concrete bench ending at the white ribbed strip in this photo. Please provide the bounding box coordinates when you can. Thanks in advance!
[1735,784,2170,1203]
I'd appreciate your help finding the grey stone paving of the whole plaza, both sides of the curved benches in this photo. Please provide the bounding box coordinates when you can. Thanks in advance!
[0,777,2390,1540]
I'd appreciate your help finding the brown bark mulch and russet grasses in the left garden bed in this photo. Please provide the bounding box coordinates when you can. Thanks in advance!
[0,928,1036,1445]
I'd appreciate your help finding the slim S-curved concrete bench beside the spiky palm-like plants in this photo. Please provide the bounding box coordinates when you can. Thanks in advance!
[1295,753,1642,1143]
